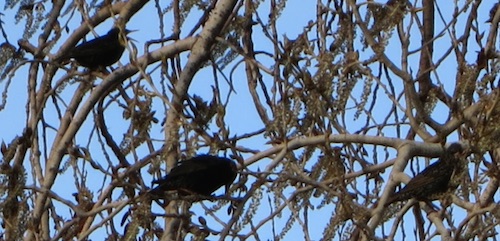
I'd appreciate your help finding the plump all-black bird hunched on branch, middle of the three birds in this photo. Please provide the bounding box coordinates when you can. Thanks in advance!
[149,155,237,199]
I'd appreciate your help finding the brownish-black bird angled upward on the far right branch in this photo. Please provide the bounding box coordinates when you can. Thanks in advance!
[385,143,465,206]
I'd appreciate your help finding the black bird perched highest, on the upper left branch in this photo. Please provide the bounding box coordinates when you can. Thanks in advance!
[68,27,131,69]
